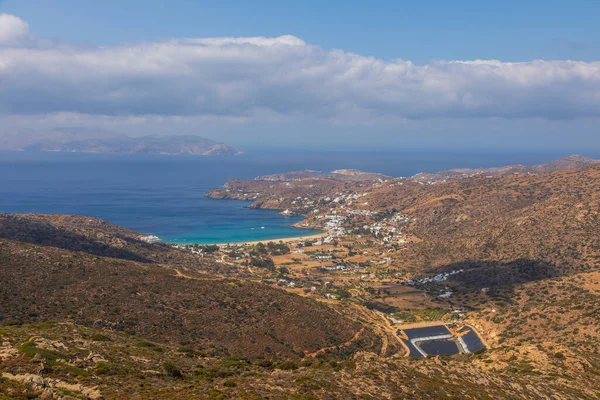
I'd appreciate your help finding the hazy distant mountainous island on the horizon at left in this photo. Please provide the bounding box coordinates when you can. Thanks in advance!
[0,129,242,156]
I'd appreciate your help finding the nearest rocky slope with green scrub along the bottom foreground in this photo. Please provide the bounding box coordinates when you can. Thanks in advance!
[0,324,598,400]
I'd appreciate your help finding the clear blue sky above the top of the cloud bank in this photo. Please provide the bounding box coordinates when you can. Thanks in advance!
[2,0,600,63]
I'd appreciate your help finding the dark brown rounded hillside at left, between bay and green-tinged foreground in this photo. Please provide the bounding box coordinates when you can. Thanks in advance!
[0,215,376,359]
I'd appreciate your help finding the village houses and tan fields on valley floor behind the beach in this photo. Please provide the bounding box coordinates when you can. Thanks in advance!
[175,194,482,353]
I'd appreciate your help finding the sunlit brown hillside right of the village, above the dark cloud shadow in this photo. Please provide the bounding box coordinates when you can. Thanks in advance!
[365,165,600,279]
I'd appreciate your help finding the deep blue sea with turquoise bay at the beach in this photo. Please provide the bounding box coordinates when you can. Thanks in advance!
[0,150,593,244]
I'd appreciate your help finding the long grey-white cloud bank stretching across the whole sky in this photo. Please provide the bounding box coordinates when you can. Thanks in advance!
[0,14,600,121]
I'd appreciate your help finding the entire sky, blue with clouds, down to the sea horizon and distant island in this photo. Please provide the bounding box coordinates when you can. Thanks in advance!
[0,0,600,152]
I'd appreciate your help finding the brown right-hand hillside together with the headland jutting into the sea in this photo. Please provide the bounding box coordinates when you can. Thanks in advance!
[207,156,600,282]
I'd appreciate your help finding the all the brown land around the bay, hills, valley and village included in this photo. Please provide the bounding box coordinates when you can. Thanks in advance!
[0,155,600,399]
